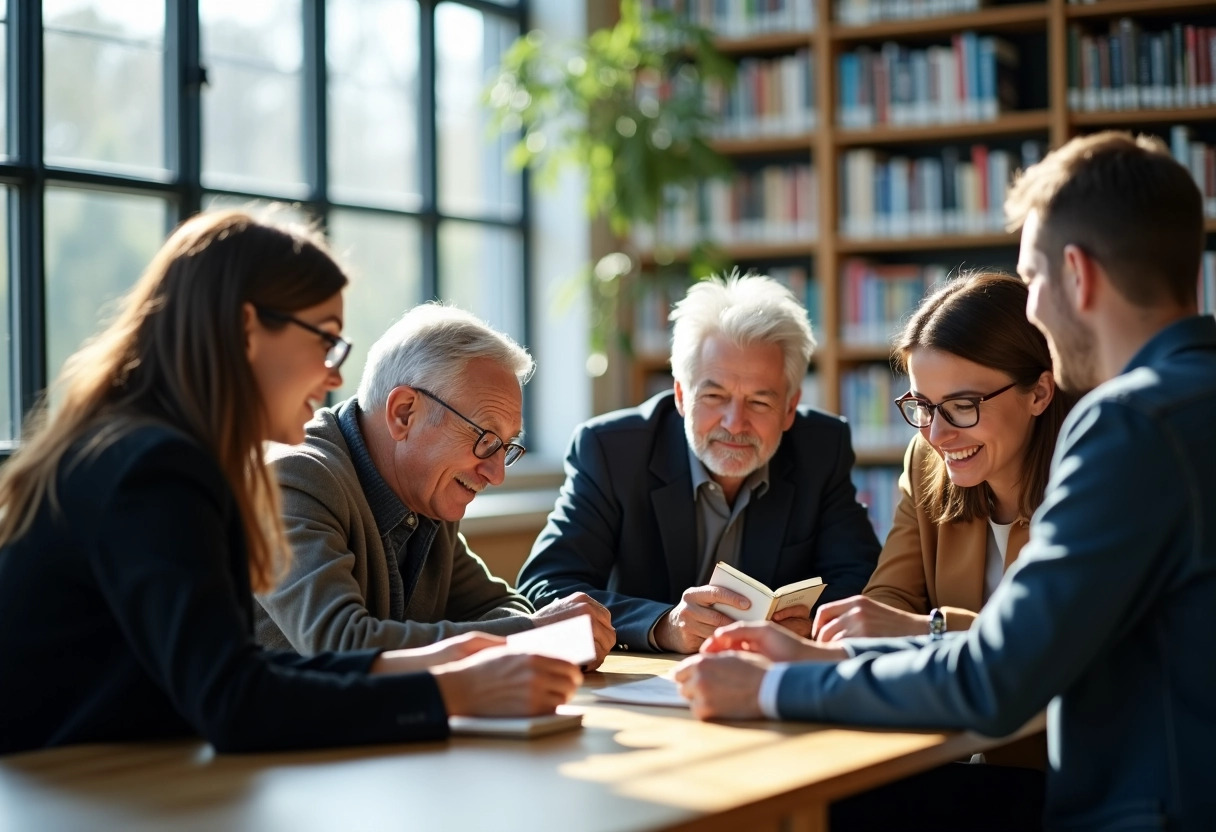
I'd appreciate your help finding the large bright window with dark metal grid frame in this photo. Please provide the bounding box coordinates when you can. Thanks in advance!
[0,0,529,445]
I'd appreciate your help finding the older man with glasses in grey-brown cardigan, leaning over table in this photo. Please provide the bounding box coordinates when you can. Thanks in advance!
[257,303,614,664]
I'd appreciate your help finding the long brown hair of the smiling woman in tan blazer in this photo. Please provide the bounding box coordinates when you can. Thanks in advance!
[891,271,1074,523]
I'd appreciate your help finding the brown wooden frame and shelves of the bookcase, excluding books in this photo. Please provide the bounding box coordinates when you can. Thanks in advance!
[617,0,1216,481]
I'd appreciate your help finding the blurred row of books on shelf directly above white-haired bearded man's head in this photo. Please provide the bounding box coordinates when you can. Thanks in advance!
[636,164,820,248]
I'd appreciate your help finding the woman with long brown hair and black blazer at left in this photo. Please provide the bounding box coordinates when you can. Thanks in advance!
[0,212,579,753]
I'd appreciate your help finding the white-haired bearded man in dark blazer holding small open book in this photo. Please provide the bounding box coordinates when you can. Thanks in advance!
[519,275,879,653]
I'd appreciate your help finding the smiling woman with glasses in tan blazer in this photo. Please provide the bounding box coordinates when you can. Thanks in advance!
[814,272,1071,641]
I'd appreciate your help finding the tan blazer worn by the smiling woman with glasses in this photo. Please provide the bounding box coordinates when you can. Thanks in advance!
[862,433,1047,769]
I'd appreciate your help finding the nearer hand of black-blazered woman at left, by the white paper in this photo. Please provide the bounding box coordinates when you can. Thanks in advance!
[430,648,582,716]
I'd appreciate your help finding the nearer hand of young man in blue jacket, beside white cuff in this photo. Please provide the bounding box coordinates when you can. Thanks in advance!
[672,653,772,719]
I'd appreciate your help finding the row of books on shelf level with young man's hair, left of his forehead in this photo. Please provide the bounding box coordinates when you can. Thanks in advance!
[839,140,1043,238]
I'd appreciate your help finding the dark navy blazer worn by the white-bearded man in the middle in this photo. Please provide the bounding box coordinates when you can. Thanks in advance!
[519,393,879,650]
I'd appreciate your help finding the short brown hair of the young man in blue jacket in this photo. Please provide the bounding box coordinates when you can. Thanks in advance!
[1004,130,1204,307]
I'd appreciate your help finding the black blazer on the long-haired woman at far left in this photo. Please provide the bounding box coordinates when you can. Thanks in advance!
[0,426,447,753]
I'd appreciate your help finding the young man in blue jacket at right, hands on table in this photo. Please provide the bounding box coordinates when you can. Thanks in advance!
[677,133,1216,830]
